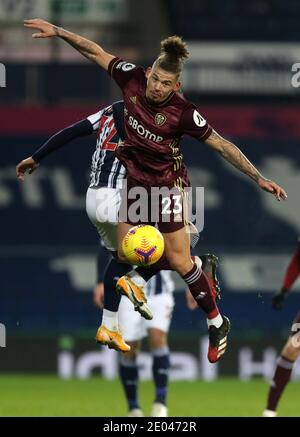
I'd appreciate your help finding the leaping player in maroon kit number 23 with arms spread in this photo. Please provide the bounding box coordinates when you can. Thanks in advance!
[24,19,287,362]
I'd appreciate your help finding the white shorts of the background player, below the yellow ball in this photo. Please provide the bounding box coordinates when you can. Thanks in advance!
[119,293,174,341]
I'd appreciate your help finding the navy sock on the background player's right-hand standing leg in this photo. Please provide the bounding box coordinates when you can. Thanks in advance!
[152,347,170,404]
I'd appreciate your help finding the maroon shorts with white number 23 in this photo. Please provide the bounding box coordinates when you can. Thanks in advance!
[119,179,188,233]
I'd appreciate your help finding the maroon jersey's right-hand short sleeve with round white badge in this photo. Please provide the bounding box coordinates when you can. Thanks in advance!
[180,104,212,141]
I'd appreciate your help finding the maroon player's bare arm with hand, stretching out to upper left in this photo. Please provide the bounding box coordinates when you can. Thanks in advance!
[24,18,115,70]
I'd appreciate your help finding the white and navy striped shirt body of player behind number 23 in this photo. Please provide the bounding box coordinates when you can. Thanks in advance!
[87,106,126,188]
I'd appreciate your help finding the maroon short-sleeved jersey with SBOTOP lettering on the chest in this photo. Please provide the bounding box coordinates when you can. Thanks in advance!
[108,58,212,187]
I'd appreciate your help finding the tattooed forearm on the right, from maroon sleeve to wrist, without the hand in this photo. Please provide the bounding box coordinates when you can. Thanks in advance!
[205,131,263,182]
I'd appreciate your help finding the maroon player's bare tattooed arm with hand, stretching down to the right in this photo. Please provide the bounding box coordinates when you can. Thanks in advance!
[205,130,287,201]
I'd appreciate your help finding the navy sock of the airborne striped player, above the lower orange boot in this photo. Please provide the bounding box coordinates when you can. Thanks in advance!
[104,258,132,312]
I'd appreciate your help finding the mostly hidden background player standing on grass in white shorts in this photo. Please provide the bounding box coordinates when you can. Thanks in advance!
[94,247,174,417]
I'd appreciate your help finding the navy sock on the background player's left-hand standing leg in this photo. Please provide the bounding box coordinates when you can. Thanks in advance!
[119,357,140,410]
